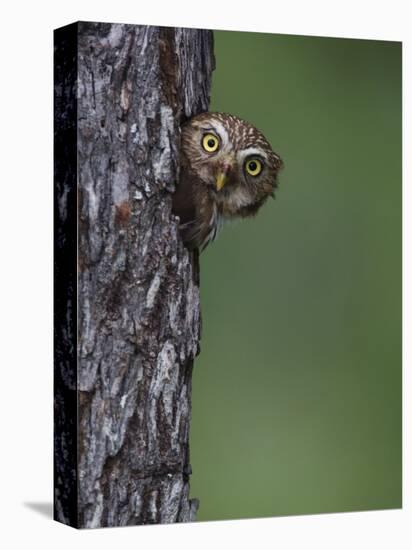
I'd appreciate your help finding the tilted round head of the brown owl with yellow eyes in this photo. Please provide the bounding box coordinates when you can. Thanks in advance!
[182,113,282,217]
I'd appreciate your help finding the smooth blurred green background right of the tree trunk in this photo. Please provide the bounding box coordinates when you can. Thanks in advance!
[191,31,402,520]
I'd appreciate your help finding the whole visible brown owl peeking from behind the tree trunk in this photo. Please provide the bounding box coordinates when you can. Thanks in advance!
[172,113,283,251]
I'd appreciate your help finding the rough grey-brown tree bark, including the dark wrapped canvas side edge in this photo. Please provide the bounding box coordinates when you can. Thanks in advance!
[55,22,213,527]
